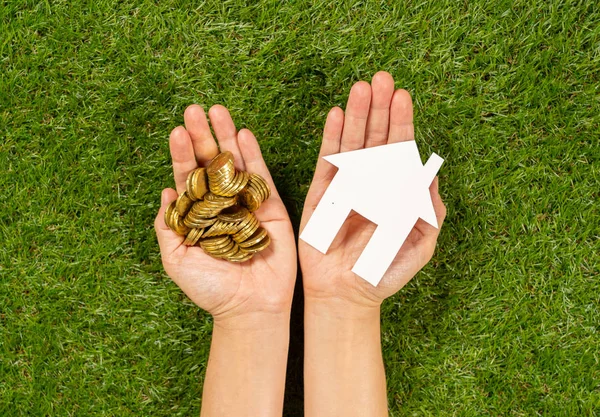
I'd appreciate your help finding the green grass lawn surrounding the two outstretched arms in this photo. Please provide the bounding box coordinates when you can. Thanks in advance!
[0,0,600,416]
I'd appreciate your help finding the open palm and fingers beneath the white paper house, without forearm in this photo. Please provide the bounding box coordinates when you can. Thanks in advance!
[298,72,446,307]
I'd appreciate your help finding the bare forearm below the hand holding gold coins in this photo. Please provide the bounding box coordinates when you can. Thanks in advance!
[200,313,289,417]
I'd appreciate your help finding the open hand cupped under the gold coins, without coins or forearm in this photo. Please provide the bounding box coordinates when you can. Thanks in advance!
[154,105,296,327]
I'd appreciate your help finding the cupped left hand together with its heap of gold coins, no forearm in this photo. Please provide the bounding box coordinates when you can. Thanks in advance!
[155,105,296,326]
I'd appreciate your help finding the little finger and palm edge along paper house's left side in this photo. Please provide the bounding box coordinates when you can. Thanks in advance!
[300,107,344,230]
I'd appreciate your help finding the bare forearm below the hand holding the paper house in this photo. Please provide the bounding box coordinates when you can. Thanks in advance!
[304,299,388,417]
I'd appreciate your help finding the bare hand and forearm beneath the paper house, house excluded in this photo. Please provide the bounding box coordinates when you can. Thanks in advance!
[298,72,446,417]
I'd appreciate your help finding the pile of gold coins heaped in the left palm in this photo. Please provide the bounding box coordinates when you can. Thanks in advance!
[165,152,271,262]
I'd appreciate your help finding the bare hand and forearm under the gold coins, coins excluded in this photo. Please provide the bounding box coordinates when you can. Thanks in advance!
[154,105,297,417]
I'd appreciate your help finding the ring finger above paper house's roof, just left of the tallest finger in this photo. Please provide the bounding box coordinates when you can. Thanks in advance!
[340,81,371,152]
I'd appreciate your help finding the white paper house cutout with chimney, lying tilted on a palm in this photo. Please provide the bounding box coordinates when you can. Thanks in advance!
[300,141,444,286]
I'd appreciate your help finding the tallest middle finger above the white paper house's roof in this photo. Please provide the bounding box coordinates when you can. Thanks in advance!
[365,71,394,148]
